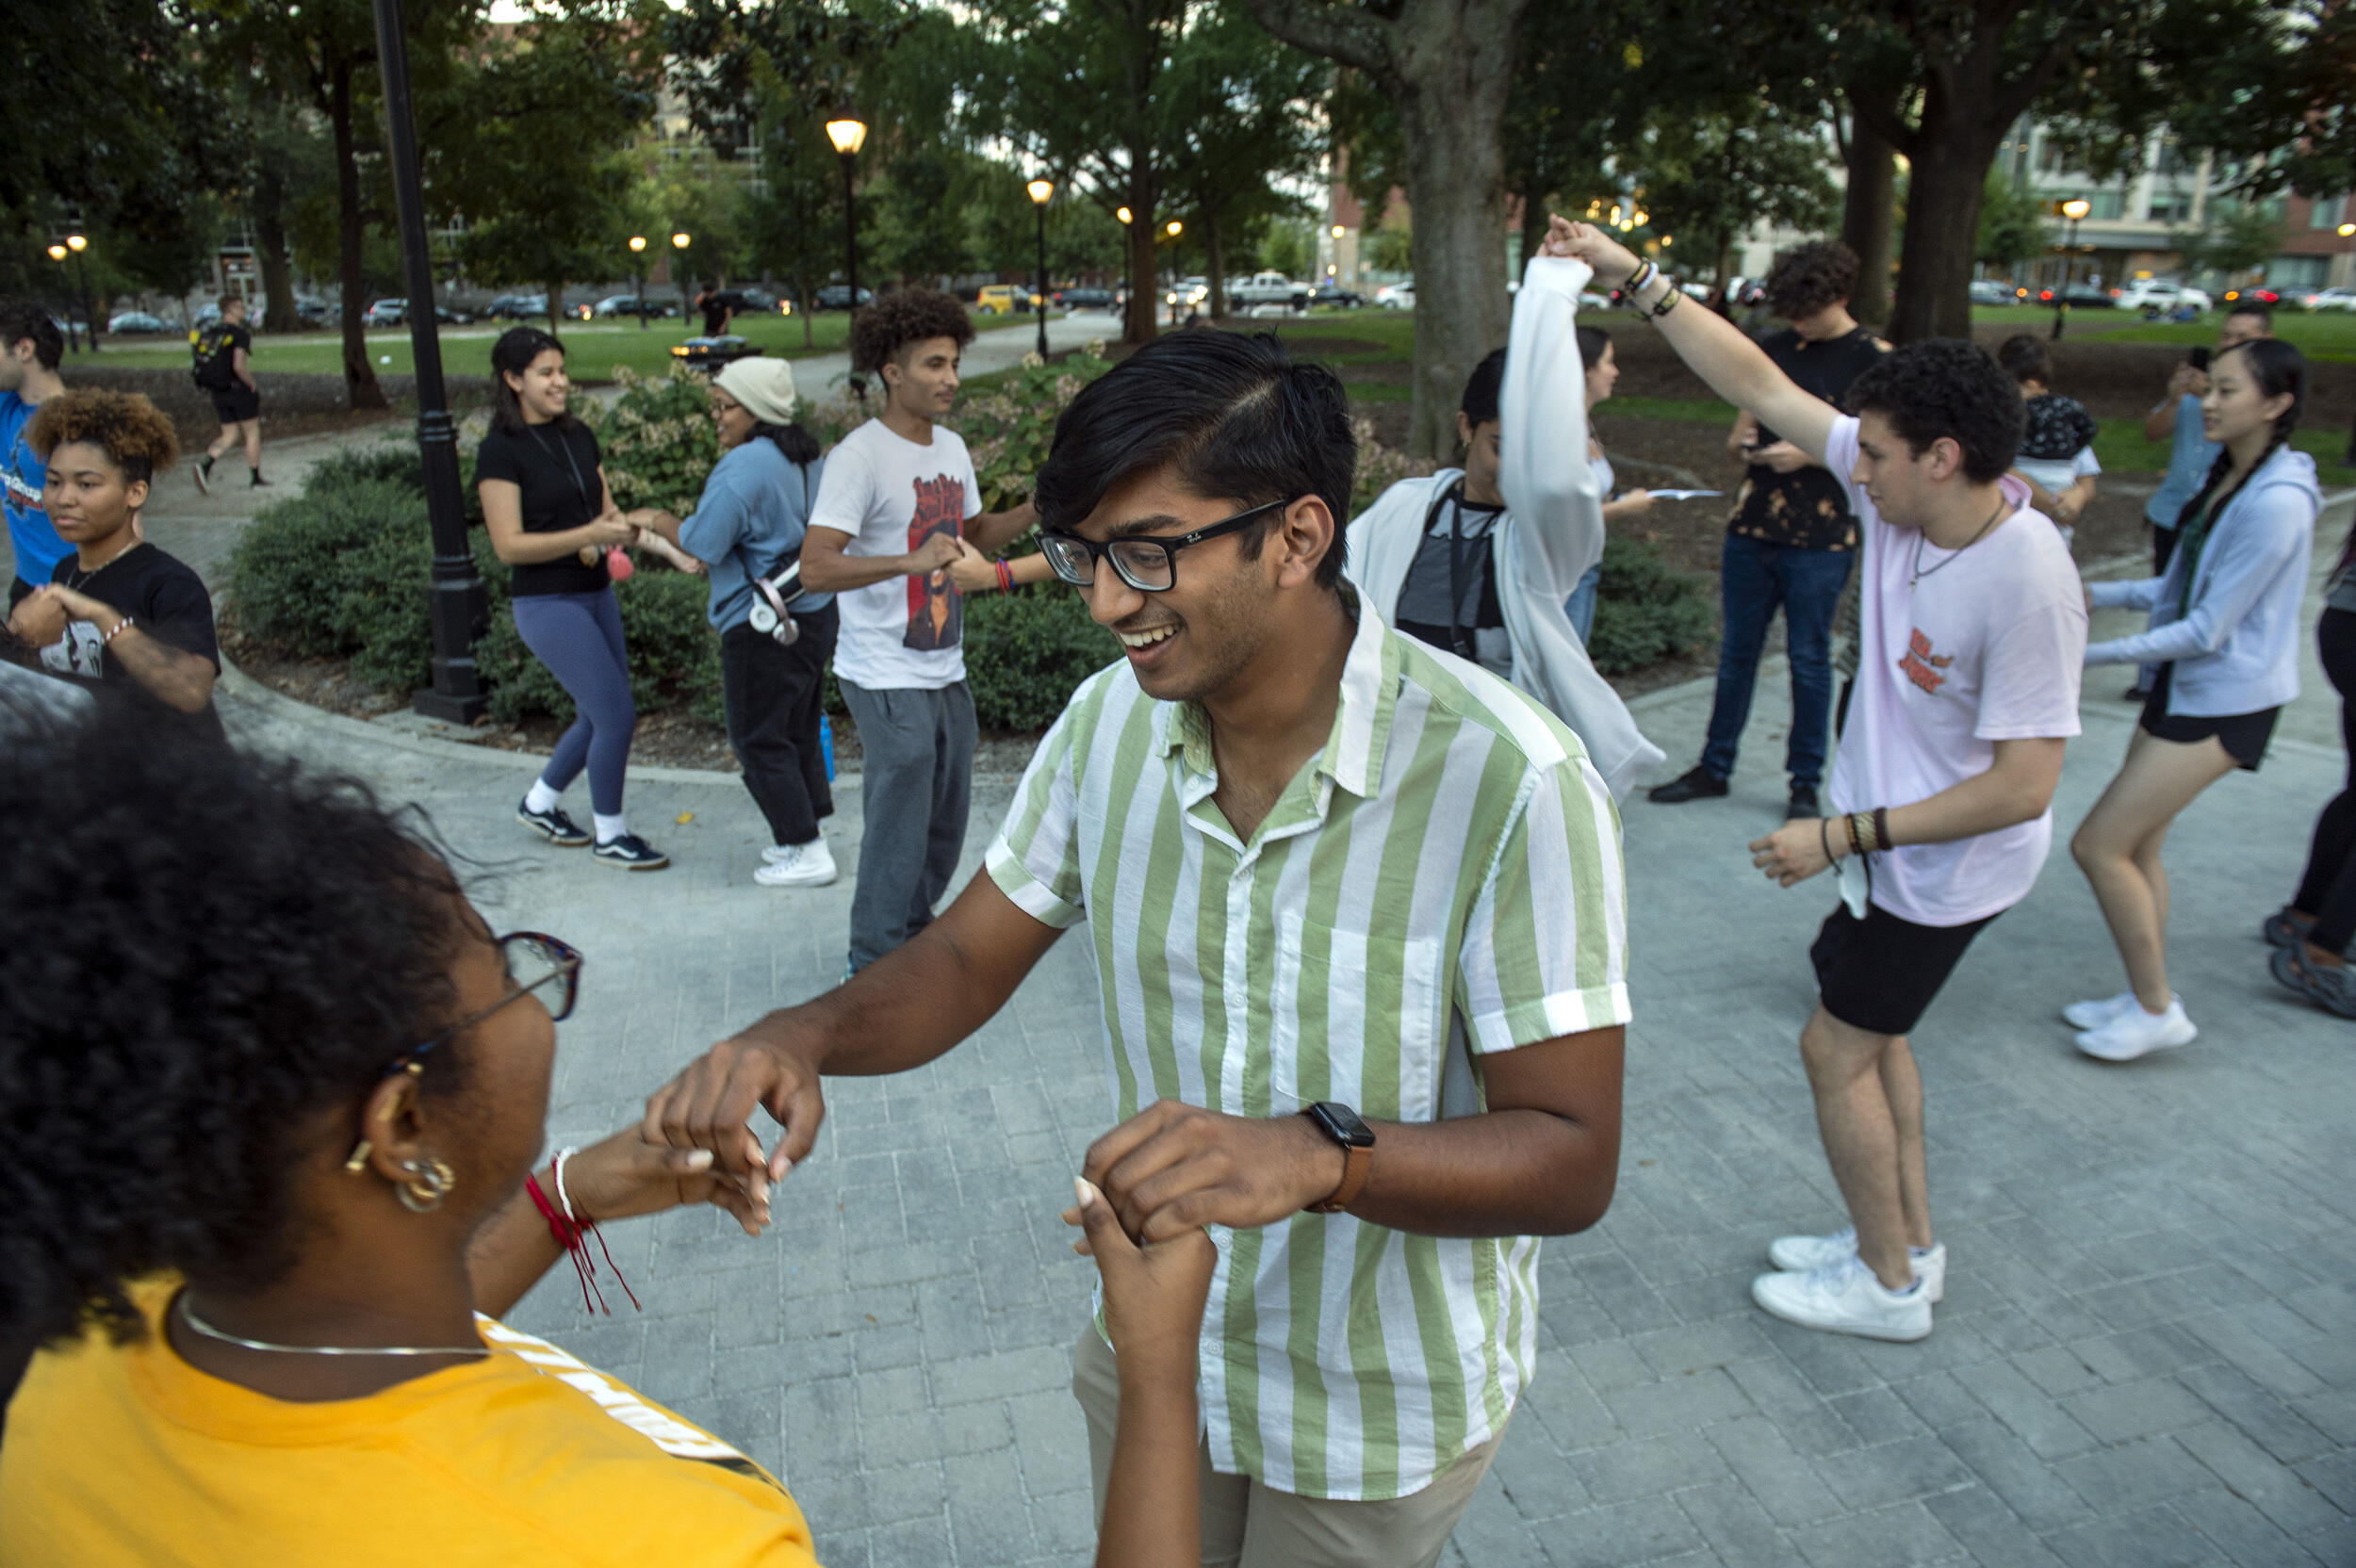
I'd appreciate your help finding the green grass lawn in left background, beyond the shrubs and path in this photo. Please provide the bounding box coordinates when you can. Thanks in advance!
[80,311,1032,382]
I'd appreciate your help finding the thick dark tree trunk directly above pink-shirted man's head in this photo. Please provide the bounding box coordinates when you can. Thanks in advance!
[1890,80,2012,344]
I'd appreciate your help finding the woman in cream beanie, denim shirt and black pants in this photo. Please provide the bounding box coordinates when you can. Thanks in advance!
[630,358,839,888]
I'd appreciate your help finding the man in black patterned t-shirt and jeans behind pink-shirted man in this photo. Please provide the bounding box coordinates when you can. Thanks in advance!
[1652,240,1890,819]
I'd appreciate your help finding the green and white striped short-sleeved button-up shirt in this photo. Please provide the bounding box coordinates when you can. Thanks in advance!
[990,605,1628,1500]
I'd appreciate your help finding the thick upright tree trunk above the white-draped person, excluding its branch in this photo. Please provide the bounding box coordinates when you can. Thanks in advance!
[1398,21,1520,457]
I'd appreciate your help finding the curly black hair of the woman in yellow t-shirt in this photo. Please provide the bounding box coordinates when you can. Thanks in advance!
[0,716,466,1356]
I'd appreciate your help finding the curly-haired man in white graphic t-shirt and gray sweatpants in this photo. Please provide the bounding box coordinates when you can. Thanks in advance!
[801,289,1032,970]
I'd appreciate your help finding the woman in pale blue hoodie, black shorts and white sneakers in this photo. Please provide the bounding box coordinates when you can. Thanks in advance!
[2062,336,2323,1062]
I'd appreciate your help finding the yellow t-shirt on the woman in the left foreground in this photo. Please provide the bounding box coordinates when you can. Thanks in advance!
[0,1281,818,1568]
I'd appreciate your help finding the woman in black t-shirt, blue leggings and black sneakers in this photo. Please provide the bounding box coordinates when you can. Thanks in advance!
[474,327,672,871]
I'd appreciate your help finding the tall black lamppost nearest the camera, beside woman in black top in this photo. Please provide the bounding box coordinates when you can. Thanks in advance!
[360,0,490,726]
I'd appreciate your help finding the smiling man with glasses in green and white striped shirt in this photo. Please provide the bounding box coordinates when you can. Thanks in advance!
[648,271,1628,1568]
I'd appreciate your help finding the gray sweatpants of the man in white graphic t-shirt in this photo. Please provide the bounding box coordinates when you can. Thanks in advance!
[837,676,975,970]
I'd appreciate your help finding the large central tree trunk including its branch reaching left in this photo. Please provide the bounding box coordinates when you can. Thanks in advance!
[1252,0,1530,457]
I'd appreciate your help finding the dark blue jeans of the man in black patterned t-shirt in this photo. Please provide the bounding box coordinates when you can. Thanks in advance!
[1701,534,1857,789]
